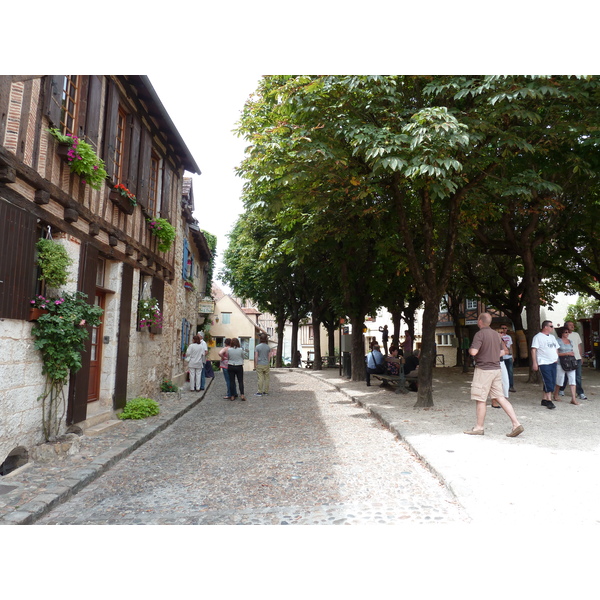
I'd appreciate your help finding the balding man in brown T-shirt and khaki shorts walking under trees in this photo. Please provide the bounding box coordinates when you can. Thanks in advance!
[464,313,524,437]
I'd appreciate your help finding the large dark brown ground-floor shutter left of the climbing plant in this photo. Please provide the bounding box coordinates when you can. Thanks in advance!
[0,199,37,320]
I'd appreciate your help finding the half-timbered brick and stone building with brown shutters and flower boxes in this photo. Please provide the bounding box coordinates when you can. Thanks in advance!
[0,75,205,463]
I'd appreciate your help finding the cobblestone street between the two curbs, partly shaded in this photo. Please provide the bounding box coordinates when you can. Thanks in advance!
[38,371,468,525]
